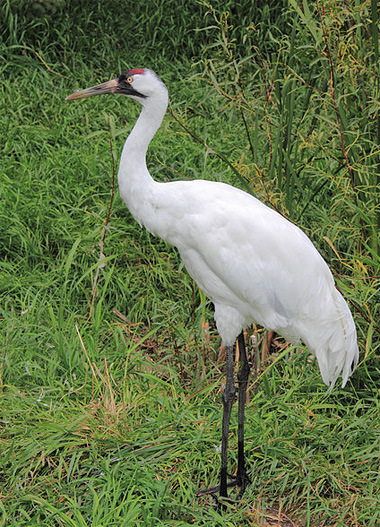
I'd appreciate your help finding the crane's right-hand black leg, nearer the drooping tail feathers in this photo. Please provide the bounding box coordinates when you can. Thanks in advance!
[236,332,251,498]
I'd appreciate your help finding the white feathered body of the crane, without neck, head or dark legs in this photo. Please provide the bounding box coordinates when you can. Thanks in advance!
[155,181,358,387]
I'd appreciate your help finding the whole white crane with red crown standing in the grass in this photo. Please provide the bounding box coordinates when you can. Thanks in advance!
[67,68,359,508]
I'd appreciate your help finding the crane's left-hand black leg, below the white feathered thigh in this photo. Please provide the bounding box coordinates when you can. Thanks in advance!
[219,346,236,498]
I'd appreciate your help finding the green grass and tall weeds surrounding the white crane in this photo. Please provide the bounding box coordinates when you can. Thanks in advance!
[0,0,380,527]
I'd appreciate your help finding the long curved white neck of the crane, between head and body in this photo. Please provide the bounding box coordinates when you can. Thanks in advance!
[118,93,168,224]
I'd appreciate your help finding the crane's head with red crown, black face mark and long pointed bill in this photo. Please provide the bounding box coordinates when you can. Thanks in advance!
[66,68,167,105]
